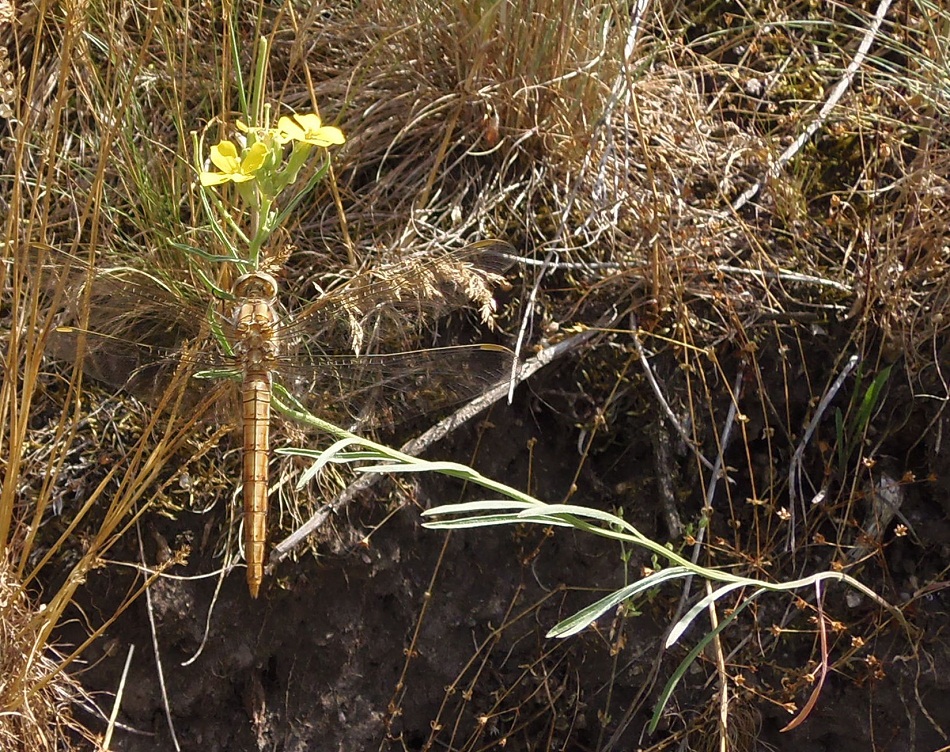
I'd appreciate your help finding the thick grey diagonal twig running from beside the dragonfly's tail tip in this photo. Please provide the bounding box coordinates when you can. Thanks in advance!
[267,329,598,574]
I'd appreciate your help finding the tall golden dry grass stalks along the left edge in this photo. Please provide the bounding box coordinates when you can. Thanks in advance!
[0,6,228,749]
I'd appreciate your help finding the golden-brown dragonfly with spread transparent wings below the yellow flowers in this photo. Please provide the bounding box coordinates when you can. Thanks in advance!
[48,240,514,598]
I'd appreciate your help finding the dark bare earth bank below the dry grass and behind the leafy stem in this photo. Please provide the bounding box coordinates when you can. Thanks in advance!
[42,324,950,752]
